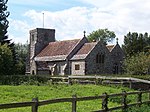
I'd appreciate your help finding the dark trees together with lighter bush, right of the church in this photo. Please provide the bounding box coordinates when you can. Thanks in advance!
[122,32,150,75]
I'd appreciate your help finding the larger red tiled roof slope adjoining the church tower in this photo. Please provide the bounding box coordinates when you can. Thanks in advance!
[37,39,80,57]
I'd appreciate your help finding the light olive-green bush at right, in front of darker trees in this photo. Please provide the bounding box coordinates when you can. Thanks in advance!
[124,52,150,75]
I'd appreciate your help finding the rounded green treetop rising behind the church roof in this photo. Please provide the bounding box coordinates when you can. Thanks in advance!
[87,28,116,44]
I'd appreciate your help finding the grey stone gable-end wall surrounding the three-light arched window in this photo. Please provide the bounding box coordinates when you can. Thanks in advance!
[85,42,111,75]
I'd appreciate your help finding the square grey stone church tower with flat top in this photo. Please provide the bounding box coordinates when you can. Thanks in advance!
[26,28,55,74]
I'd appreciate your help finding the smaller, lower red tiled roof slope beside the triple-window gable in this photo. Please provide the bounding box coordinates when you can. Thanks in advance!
[76,42,97,55]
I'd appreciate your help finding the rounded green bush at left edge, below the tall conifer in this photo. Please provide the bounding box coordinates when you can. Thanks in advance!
[0,44,13,75]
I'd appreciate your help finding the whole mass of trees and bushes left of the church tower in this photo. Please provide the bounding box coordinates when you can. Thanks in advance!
[0,0,28,75]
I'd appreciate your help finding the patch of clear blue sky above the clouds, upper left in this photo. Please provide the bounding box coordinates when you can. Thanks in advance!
[8,0,90,19]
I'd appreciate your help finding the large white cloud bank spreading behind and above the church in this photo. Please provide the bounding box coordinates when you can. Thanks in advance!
[9,0,150,43]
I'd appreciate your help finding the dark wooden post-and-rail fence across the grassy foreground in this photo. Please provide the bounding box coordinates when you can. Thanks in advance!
[0,91,150,112]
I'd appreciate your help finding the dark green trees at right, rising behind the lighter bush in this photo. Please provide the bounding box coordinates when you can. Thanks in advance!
[122,32,150,56]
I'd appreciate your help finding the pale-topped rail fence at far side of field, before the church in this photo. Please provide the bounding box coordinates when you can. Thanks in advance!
[50,76,150,90]
